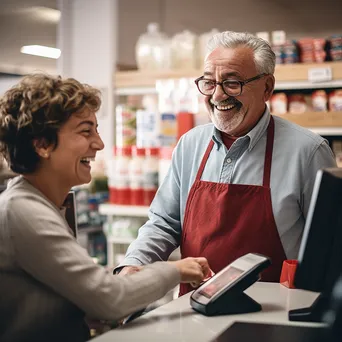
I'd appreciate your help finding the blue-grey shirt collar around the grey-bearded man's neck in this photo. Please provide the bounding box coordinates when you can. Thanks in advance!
[212,107,270,152]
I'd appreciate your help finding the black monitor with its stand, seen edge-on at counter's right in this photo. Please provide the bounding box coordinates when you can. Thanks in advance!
[289,168,342,322]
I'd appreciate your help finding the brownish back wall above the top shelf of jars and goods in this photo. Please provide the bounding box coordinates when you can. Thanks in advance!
[118,0,342,65]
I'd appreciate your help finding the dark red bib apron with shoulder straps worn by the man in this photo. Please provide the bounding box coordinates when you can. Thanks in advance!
[180,116,286,295]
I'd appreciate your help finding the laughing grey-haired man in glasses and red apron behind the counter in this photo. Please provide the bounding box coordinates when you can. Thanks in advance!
[116,32,335,294]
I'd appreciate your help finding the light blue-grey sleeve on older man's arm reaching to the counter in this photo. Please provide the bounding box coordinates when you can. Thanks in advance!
[114,138,186,272]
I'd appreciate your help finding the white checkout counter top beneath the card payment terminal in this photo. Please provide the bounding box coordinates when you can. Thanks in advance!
[91,282,323,342]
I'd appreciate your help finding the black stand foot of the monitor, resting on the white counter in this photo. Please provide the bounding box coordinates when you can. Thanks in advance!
[289,294,330,322]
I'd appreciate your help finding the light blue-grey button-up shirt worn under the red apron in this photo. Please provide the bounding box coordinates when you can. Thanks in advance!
[121,110,336,266]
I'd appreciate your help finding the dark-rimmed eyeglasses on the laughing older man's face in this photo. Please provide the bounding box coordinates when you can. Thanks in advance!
[195,74,267,96]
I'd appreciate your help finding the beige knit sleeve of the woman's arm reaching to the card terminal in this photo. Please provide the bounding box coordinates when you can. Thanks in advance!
[6,197,180,320]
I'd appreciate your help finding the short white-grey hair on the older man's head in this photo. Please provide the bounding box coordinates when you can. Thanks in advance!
[207,31,275,75]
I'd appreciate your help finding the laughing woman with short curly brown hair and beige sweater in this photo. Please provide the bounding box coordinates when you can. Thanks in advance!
[0,74,209,342]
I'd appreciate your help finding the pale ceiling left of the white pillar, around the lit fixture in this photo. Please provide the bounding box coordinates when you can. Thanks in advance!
[0,0,57,74]
